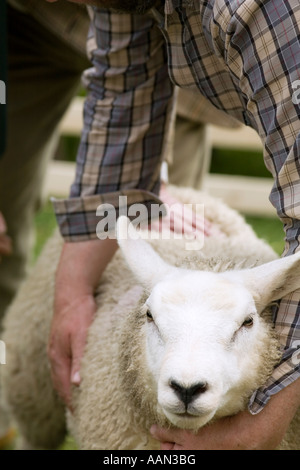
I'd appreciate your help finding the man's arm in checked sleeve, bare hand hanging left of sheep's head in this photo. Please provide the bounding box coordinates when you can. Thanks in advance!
[49,8,173,407]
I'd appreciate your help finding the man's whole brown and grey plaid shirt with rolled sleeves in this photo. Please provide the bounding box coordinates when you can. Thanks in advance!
[55,0,300,413]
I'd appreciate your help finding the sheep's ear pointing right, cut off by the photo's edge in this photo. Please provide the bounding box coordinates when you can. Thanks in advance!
[227,252,300,311]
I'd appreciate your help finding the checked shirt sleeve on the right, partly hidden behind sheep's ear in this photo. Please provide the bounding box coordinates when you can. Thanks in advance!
[216,0,300,413]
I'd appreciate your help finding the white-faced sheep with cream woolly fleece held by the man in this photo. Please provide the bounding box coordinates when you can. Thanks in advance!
[2,186,300,450]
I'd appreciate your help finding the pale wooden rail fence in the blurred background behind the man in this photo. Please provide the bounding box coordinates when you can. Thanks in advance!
[46,97,276,216]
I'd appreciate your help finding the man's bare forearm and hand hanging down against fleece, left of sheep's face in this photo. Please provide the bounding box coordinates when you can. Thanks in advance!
[48,239,117,409]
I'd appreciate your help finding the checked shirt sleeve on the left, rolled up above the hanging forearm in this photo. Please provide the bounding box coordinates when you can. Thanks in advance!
[53,7,174,241]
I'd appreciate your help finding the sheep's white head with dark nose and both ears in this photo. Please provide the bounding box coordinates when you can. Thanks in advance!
[118,217,300,429]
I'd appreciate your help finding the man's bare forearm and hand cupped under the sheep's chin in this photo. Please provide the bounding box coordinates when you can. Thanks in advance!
[151,379,300,450]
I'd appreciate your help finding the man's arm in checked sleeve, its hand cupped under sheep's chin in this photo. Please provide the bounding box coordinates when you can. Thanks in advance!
[154,0,300,449]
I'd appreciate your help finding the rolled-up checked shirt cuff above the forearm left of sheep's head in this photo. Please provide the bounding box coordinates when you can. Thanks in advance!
[51,189,166,242]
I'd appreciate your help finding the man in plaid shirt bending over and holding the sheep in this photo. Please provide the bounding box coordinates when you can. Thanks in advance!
[4,0,300,449]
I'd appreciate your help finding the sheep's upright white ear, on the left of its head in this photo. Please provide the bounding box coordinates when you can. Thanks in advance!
[117,216,175,288]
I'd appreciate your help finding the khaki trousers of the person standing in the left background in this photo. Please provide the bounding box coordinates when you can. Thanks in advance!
[0,2,90,319]
